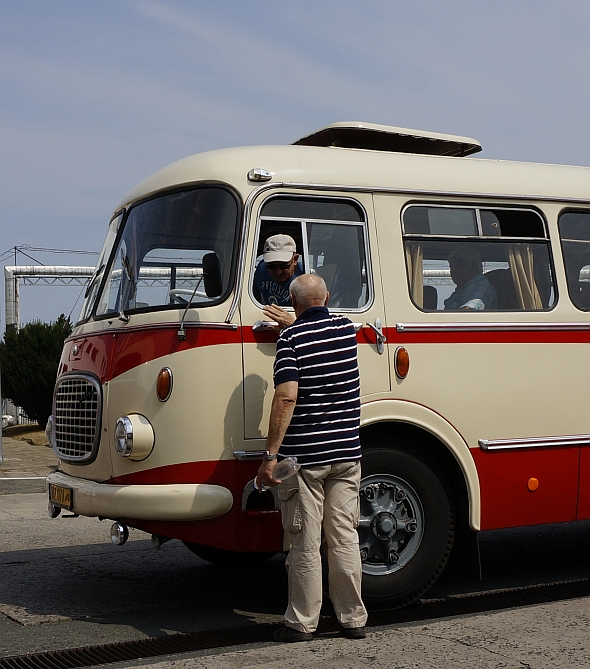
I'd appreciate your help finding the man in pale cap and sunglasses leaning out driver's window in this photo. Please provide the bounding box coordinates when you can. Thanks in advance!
[254,235,303,307]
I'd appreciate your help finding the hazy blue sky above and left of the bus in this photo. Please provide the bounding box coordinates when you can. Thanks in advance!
[0,0,590,323]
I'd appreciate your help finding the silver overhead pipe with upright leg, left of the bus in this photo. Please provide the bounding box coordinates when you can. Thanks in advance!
[4,265,94,330]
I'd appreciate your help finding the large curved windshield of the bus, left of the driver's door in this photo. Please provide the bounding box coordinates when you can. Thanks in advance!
[95,186,238,317]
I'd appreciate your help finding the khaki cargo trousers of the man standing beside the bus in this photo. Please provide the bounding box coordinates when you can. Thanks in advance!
[278,460,367,632]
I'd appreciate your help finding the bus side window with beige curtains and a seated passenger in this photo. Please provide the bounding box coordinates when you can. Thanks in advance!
[402,205,555,311]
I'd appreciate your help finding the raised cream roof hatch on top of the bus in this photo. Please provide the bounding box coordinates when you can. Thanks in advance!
[293,121,481,156]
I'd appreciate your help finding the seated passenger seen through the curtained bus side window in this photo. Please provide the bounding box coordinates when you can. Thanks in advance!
[445,246,498,311]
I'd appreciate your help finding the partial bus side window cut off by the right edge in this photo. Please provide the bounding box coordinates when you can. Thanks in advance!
[559,211,590,311]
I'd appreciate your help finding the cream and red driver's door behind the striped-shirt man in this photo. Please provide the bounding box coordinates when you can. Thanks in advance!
[241,193,390,447]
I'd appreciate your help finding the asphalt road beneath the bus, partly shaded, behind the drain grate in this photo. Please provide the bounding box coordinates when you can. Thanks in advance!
[0,492,590,656]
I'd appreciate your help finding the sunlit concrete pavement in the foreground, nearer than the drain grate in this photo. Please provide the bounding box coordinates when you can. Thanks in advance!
[111,598,590,669]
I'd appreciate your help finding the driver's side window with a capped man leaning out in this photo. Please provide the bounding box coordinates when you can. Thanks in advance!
[252,196,370,309]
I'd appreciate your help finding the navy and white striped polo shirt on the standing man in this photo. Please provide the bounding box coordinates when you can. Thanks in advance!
[274,307,361,467]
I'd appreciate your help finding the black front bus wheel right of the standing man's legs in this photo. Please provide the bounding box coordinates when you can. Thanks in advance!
[359,442,454,606]
